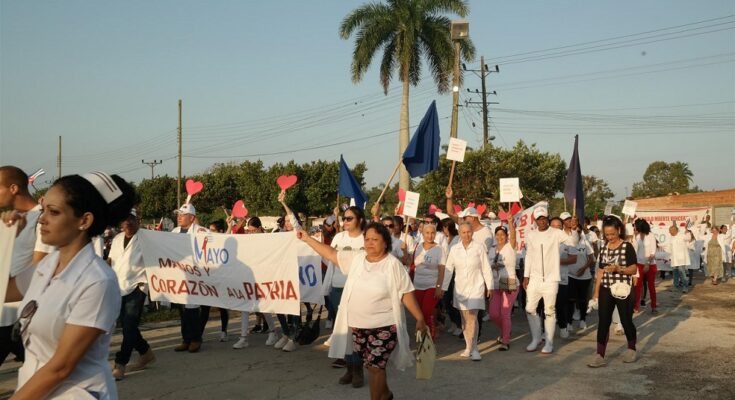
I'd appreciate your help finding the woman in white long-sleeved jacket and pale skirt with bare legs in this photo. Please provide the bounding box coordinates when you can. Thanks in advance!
[445,222,493,361]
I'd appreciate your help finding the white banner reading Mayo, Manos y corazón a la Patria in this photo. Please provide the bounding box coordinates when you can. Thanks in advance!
[138,230,323,315]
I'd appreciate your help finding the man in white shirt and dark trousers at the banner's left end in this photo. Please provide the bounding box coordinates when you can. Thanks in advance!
[107,209,156,381]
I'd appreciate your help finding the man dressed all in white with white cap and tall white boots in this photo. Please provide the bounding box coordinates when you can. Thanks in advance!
[523,206,574,354]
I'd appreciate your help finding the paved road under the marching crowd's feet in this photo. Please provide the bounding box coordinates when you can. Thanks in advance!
[0,277,735,400]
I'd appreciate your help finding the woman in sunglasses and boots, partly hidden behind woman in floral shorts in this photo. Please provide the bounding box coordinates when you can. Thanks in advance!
[324,206,365,388]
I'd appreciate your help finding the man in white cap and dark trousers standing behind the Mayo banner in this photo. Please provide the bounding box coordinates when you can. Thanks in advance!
[171,203,209,353]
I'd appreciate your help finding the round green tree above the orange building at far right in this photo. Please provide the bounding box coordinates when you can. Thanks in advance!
[632,161,701,197]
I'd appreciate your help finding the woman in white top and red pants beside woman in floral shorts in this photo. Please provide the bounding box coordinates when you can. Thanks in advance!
[401,224,449,339]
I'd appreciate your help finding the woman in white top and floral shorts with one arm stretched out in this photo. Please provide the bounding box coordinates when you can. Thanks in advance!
[298,222,427,400]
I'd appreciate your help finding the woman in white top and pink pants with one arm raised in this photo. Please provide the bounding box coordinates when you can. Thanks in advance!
[489,217,518,351]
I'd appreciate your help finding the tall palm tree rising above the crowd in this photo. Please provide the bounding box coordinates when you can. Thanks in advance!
[339,0,475,190]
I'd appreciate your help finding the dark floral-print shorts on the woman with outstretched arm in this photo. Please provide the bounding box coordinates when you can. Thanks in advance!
[352,325,398,369]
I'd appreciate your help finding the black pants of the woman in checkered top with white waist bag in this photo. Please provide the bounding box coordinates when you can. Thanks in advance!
[597,287,637,357]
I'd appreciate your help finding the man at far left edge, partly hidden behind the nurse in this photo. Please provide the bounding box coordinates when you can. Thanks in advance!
[0,165,54,365]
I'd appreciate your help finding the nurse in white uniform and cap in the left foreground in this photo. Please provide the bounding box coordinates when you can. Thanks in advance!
[3,172,135,399]
